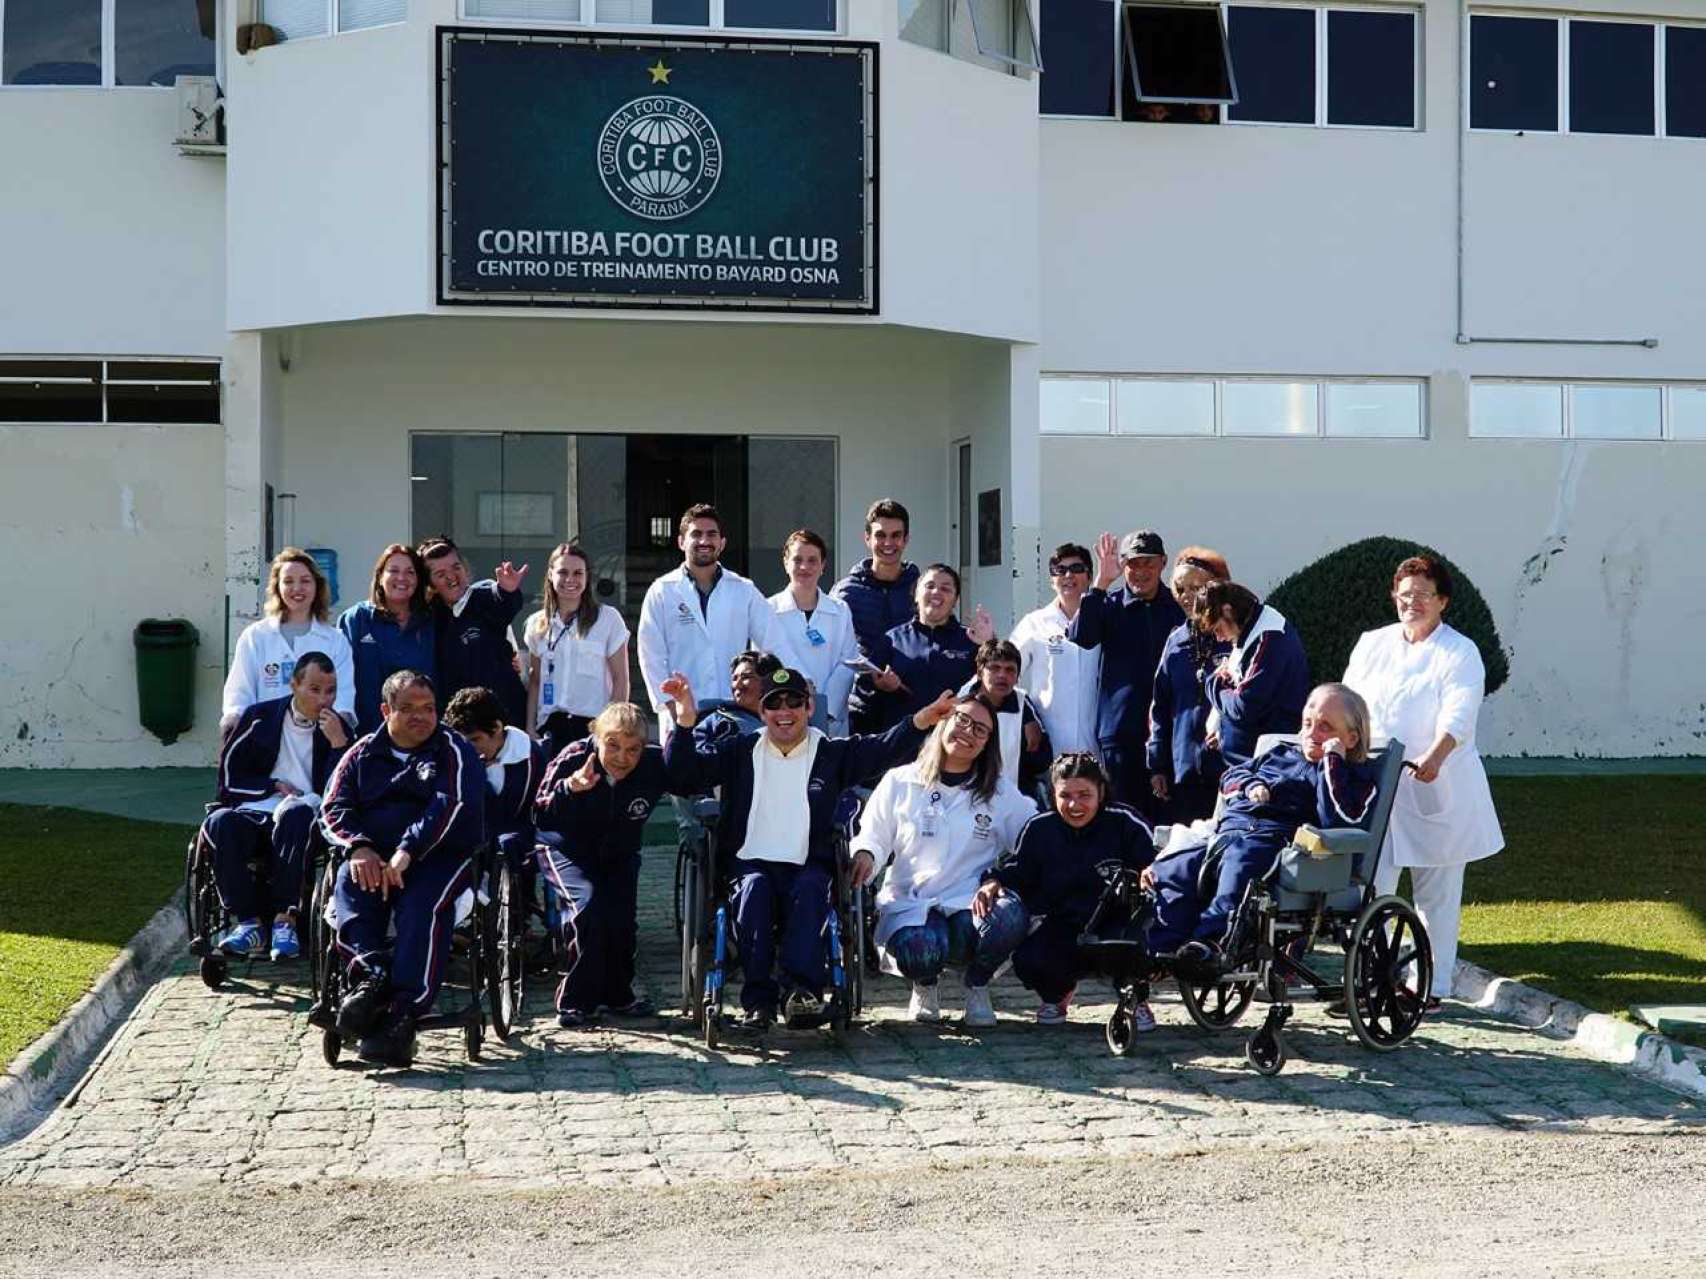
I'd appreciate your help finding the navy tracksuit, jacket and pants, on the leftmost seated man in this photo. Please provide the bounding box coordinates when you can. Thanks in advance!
[201,694,348,919]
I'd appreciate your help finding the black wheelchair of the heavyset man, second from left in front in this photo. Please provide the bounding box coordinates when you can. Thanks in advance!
[305,844,522,1066]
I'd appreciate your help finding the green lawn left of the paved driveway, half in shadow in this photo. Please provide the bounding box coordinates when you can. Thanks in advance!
[0,803,194,1062]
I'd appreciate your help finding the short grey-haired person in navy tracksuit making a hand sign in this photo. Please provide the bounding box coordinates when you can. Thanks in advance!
[534,701,667,1028]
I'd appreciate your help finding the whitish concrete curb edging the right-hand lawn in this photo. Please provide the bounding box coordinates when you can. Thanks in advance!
[1455,960,1706,1098]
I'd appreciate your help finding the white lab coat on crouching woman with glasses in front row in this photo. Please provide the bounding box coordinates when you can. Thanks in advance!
[853,764,1037,975]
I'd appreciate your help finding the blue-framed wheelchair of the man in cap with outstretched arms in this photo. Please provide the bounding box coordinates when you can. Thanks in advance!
[681,798,868,1050]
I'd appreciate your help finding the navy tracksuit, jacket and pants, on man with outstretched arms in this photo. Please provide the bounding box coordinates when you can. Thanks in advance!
[664,718,923,1011]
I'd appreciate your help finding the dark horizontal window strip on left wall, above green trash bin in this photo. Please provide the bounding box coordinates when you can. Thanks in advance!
[0,360,220,425]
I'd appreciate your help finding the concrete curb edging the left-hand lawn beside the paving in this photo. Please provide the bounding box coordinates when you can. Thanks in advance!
[0,899,189,1144]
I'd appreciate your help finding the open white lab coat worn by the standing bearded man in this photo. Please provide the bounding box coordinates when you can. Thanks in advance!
[640,564,775,716]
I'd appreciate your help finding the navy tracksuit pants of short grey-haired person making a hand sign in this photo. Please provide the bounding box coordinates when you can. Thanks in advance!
[537,844,640,1016]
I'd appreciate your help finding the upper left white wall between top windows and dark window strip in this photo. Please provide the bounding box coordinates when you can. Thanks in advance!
[0,87,225,356]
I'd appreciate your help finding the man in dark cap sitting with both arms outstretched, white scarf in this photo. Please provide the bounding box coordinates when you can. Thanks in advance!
[662,667,954,1030]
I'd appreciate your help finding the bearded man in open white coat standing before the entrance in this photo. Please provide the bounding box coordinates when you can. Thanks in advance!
[640,503,775,735]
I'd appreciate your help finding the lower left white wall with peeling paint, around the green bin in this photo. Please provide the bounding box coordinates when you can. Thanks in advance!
[0,426,225,767]
